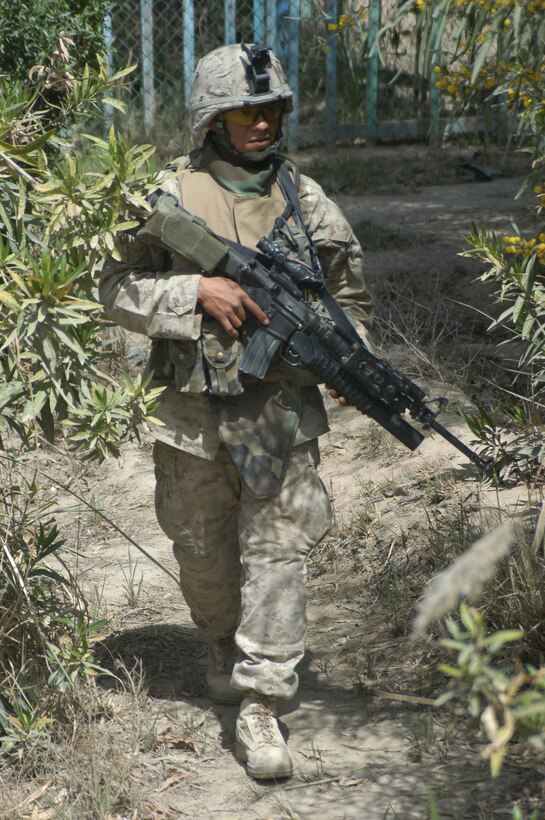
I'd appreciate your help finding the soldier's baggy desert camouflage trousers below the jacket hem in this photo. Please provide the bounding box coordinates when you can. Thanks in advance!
[154,439,331,698]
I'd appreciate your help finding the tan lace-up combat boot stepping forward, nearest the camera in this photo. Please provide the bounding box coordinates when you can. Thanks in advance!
[236,692,293,780]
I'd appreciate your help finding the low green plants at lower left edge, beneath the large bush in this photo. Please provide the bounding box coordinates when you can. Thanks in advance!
[0,468,103,761]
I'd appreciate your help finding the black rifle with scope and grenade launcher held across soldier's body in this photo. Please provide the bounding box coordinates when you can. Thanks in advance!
[137,191,489,470]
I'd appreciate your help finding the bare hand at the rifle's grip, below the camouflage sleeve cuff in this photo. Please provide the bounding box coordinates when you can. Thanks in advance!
[197,276,269,336]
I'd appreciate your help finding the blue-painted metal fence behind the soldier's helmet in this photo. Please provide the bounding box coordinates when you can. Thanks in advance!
[105,0,484,149]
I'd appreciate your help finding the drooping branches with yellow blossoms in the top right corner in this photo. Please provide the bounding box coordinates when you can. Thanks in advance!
[380,0,545,143]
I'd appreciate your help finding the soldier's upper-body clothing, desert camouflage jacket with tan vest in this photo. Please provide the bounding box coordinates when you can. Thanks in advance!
[99,146,371,494]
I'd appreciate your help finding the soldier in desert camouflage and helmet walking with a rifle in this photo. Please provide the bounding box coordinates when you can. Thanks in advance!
[100,44,370,779]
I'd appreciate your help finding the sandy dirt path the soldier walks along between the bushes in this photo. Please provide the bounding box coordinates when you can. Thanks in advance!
[11,170,540,820]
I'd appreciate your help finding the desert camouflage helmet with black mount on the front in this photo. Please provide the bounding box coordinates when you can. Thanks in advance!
[189,43,293,131]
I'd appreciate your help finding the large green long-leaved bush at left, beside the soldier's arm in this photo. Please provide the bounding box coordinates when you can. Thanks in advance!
[0,41,164,458]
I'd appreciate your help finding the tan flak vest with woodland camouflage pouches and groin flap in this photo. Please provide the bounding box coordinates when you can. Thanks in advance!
[147,156,328,498]
